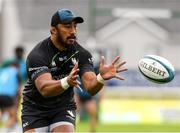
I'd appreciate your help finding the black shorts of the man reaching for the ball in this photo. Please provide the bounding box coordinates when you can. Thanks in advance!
[21,106,76,132]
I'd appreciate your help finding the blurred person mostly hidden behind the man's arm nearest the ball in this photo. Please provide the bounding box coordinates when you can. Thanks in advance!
[75,52,103,132]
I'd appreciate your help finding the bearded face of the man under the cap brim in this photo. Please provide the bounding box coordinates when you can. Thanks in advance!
[56,22,77,48]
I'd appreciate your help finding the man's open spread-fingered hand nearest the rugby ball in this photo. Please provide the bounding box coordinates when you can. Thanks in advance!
[99,56,128,80]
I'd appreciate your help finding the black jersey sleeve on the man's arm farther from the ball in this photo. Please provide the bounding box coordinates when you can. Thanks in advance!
[26,53,50,82]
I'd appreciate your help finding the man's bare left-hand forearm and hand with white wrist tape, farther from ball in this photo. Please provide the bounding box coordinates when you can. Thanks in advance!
[35,63,79,97]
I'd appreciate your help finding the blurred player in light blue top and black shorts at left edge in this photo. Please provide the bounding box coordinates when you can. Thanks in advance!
[0,60,20,131]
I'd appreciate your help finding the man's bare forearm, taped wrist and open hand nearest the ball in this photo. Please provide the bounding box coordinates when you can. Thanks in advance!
[81,56,127,95]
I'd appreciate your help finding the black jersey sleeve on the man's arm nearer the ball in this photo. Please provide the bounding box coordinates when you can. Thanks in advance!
[79,51,94,76]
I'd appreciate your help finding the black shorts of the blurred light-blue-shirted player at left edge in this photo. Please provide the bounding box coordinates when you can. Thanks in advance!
[0,95,15,109]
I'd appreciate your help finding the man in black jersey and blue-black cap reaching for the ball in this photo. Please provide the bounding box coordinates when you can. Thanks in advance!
[21,9,127,132]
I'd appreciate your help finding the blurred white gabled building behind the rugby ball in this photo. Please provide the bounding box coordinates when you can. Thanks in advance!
[96,12,180,69]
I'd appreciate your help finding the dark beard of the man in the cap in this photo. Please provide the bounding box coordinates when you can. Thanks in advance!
[57,31,77,48]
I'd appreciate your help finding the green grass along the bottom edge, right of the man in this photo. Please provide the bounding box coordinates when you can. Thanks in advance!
[76,122,180,132]
